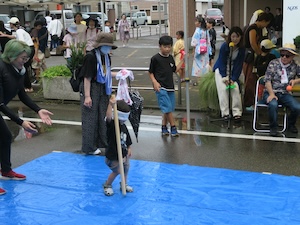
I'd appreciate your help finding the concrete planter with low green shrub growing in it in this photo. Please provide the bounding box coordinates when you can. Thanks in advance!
[41,65,80,100]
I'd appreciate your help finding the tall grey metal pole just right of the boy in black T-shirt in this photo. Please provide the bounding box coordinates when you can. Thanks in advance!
[183,0,191,130]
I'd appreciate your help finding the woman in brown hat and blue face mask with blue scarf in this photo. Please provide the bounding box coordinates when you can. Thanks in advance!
[80,32,117,154]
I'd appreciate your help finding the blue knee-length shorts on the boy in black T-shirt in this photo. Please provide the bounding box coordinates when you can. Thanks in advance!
[155,89,175,113]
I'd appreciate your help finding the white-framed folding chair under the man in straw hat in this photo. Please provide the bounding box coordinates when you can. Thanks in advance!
[253,76,287,133]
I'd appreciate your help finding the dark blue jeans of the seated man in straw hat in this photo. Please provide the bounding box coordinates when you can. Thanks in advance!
[263,92,300,129]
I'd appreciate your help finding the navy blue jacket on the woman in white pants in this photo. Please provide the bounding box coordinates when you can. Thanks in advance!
[213,42,245,81]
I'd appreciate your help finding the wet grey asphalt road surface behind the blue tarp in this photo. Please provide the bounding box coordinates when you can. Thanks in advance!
[8,26,300,176]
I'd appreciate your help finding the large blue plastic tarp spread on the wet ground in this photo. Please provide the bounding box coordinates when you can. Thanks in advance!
[0,153,300,225]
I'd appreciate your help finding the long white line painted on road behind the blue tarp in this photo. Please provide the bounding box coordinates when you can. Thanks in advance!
[3,116,300,143]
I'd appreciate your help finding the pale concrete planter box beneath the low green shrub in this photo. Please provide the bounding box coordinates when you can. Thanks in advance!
[42,77,80,101]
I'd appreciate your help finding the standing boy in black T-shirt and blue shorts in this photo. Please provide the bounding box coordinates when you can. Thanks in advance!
[149,36,184,137]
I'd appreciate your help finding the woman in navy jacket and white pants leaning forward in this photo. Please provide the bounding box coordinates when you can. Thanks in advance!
[213,27,245,120]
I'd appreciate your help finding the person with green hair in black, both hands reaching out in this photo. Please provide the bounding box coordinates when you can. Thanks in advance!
[0,40,52,195]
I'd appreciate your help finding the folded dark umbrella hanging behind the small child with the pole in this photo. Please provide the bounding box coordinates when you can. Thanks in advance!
[129,85,144,142]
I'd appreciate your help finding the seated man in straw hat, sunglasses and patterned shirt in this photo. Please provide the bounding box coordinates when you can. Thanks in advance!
[263,43,300,137]
